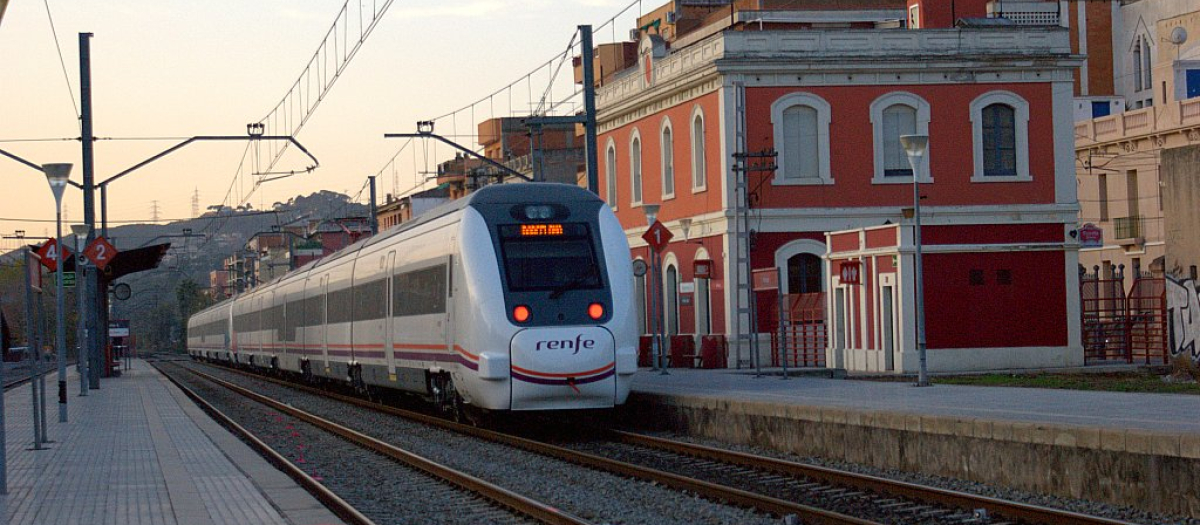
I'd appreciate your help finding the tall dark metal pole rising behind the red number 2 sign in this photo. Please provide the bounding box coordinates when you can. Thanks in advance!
[80,32,102,388]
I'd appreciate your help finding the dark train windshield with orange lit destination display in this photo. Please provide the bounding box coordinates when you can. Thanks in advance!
[500,224,604,295]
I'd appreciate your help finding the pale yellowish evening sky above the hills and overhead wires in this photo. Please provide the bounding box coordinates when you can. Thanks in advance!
[0,0,643,249]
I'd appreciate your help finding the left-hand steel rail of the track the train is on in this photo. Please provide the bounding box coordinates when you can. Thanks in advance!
[194,361,878,525]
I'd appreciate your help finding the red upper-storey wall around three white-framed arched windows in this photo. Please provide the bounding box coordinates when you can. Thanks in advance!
[746,83,1055,207]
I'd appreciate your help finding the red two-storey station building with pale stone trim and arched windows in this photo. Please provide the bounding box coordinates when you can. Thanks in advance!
[590,0,1082,373]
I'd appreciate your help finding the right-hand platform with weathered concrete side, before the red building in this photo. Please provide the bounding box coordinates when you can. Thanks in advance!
[622,369,1200,517]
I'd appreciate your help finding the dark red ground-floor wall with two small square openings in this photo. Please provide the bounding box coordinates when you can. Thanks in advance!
[924,252,1067,349]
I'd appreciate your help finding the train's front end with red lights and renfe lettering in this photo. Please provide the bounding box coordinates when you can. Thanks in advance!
[481,195,636,410]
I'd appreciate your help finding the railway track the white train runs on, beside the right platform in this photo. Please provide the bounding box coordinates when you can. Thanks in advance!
[177,361,1142,525]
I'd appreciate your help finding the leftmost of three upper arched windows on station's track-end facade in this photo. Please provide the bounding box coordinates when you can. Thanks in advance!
[770,93,833,185]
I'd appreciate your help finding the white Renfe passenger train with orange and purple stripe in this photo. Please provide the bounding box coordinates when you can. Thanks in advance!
[187,183,637,414]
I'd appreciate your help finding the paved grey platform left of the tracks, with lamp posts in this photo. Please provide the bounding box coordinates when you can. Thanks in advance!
[0,360,342,525]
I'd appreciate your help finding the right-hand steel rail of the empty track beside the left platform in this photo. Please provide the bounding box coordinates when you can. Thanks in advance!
[172,361,592,525]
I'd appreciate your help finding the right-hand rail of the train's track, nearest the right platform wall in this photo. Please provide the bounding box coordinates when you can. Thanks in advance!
[608,430,1134,525]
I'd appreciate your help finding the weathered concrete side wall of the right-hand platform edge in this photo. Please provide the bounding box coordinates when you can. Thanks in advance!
[623,393,1200,517]
